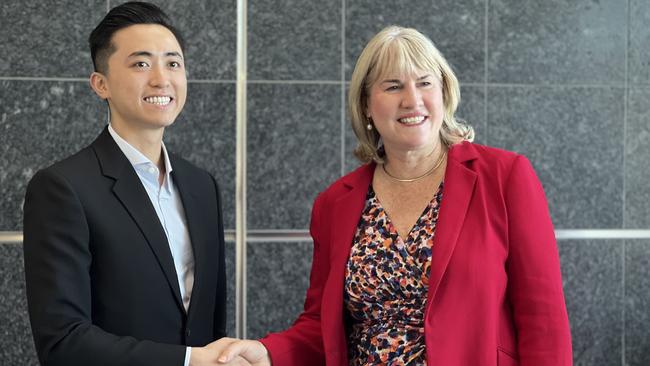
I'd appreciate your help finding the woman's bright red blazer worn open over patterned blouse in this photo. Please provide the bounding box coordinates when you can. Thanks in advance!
[261,142,572,366]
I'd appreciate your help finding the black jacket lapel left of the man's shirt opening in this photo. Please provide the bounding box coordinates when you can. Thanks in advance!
[92,128,184,309]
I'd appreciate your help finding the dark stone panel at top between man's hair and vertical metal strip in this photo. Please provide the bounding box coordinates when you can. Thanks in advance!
[111,0,237,80]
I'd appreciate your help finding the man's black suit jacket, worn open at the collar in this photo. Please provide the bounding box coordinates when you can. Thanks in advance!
[24,129,226,366]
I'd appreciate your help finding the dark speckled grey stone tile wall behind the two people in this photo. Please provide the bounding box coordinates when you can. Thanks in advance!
[0,0,650,366]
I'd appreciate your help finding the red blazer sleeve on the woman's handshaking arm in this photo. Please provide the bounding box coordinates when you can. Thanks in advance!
[260,194,329,366]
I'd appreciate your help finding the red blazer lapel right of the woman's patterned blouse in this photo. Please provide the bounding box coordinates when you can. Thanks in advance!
[425,143,477,319]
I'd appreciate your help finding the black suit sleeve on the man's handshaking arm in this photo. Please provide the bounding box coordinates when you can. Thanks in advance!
[24,169,185,366]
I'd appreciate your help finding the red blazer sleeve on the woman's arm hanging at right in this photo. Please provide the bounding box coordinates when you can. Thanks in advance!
[505,156,572,366]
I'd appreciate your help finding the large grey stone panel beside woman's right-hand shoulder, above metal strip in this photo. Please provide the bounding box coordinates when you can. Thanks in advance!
[488,87,624,229]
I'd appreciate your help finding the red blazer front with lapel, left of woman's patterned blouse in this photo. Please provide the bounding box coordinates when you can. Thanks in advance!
[321,164,375,364]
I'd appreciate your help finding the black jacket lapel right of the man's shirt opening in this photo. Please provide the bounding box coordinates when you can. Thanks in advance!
[169,154,209,313]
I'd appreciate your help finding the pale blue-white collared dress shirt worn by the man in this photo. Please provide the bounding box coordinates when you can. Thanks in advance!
[108,124,194,366]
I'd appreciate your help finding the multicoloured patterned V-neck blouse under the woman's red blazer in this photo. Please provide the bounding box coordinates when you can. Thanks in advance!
[344,183,443,365]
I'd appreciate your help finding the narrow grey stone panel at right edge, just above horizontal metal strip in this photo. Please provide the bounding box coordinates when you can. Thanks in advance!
[625,88,650,229]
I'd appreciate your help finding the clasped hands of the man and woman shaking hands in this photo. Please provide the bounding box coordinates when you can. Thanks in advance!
[190,338,271,366]
